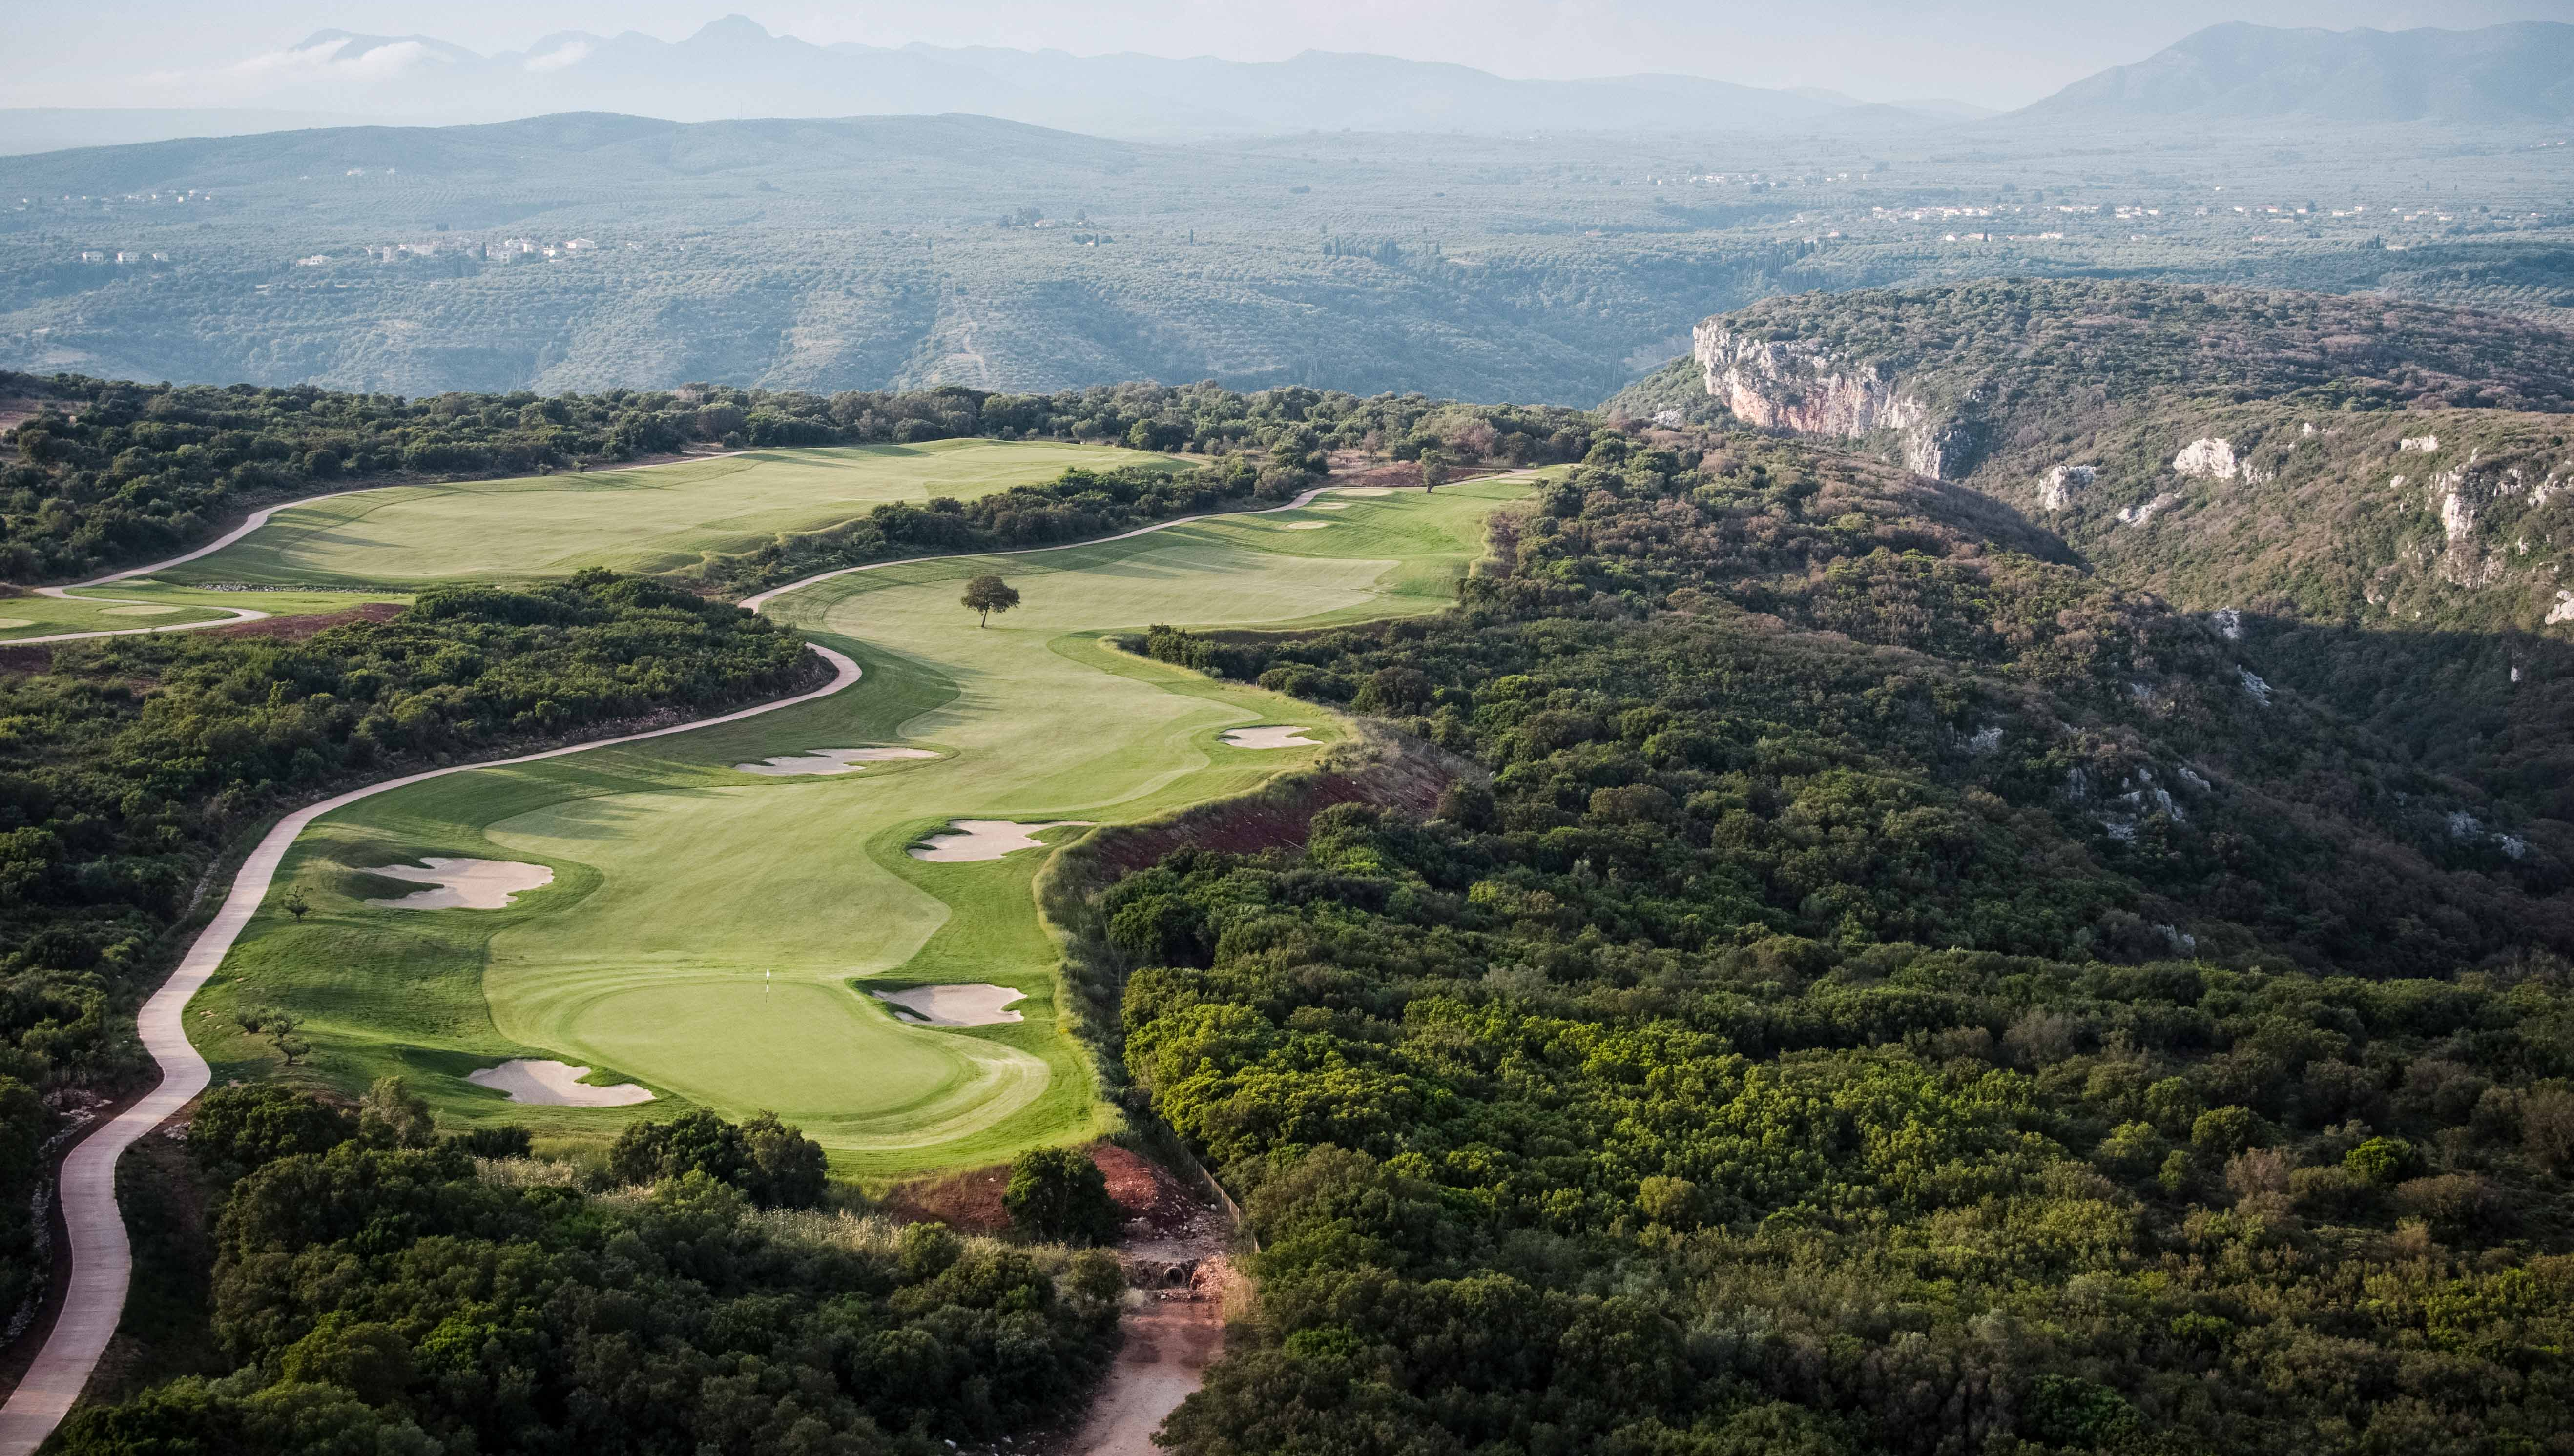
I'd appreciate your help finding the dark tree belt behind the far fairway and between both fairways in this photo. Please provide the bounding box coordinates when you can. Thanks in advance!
[0,373,1591,584]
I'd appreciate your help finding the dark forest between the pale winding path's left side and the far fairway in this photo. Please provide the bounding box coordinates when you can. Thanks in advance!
[0,571,811,1337]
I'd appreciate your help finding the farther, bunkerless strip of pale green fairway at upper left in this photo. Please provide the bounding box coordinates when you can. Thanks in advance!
[167,440,1184,587]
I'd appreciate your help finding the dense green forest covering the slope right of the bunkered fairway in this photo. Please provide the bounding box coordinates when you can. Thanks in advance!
[1101,435,2574,1456]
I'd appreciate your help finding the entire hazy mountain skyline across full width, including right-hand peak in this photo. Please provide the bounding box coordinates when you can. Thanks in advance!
[0,16,2574,154]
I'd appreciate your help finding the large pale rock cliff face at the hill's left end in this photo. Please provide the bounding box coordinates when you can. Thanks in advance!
[1694,319,1985,481]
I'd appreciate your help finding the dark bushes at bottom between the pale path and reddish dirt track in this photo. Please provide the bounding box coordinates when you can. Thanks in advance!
[51,1096,1125,1456]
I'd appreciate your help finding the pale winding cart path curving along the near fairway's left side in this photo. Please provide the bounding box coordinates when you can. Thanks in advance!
[0,643,862,1456]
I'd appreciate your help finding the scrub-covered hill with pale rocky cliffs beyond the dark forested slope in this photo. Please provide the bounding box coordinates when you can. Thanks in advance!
[1609,280,2574,818]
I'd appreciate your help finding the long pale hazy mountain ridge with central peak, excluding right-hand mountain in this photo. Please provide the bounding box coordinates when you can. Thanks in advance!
[15,16,1987,152]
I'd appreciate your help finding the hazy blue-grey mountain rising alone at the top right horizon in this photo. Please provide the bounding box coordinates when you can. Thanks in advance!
[2015,21,2574,123]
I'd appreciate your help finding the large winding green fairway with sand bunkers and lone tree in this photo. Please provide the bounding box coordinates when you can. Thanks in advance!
[188,478,1529,1178]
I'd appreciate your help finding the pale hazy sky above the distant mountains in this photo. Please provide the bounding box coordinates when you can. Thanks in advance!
[0,0,2574,105]
